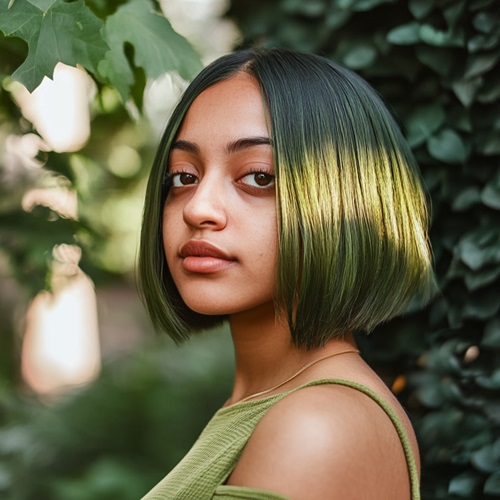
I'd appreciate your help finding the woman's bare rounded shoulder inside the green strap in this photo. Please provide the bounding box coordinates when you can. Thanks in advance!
[229,384,410,500]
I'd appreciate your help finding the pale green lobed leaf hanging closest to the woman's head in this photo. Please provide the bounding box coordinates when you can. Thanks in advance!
[99,0,202,101]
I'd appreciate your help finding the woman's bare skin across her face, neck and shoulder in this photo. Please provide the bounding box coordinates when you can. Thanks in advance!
[163,73,418,500]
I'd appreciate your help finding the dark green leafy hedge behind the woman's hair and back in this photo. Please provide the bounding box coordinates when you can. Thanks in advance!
[229,0,500,500]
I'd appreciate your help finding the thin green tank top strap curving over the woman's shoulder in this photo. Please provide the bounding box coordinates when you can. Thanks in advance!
[286,378,420,500]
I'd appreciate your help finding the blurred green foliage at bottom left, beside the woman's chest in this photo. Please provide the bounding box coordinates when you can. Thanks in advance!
[0,331,232,500]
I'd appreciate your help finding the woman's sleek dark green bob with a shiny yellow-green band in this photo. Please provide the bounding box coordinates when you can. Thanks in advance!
[139,49,436,348]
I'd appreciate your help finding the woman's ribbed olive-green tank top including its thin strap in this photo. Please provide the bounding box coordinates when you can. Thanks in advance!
[142,379,420,500]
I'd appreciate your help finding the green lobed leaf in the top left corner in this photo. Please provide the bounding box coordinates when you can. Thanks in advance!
[0,0,108,92]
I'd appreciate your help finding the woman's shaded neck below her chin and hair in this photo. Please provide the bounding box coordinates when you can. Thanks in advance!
[227,307,356,404]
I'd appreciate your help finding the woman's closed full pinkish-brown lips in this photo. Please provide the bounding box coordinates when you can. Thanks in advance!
[179,240,236,274]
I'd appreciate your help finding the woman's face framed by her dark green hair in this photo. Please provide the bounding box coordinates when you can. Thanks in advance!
[163,73,277,315]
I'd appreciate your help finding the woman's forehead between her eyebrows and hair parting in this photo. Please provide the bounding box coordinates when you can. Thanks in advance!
[177,73,269,141]
